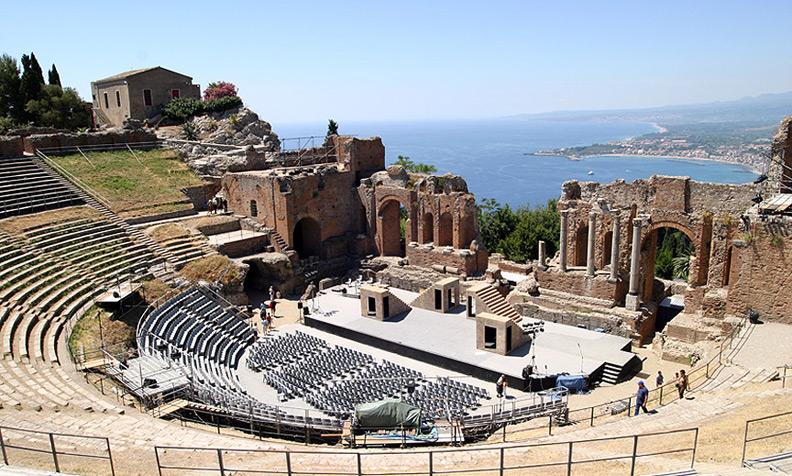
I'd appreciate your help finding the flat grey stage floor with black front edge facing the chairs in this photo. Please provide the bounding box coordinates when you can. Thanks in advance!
[305,288,637,389]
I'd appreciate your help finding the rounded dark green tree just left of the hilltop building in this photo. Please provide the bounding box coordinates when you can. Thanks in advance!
[25,85,91,129]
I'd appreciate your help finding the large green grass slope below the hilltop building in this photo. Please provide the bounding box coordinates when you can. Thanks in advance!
[53,149,202,216]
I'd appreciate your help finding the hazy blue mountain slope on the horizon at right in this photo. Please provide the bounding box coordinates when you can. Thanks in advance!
[509,91,792,125]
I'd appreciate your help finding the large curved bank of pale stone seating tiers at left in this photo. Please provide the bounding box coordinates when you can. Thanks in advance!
[0,208,164,411]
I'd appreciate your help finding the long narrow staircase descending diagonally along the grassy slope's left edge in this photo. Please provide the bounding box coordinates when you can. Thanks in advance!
[33,150,178,280]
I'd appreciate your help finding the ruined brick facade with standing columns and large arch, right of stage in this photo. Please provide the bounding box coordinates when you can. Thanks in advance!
[510,176,754,343]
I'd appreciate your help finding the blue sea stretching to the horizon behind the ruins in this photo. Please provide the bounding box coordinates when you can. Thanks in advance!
[273,119,756,207]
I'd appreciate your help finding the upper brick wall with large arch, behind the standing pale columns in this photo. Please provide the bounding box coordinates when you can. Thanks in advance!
[559,176,754,297]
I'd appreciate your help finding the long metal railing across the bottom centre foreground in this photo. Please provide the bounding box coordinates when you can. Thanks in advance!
[154,428,698,476]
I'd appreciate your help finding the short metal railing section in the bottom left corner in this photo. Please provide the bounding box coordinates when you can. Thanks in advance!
[0,426,115,475]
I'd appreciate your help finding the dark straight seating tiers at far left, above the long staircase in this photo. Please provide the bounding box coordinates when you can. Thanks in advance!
[0,157,83,218]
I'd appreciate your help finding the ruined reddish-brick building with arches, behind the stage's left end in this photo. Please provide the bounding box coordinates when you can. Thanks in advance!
[222,136,486,274]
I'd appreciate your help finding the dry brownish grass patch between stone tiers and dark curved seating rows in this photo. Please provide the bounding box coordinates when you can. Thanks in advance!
[69,306,135,358]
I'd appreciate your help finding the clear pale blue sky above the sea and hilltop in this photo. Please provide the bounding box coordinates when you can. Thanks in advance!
[0,0,792,123]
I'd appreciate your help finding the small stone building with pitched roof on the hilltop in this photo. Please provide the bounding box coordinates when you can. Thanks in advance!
[91,66,201,127]
